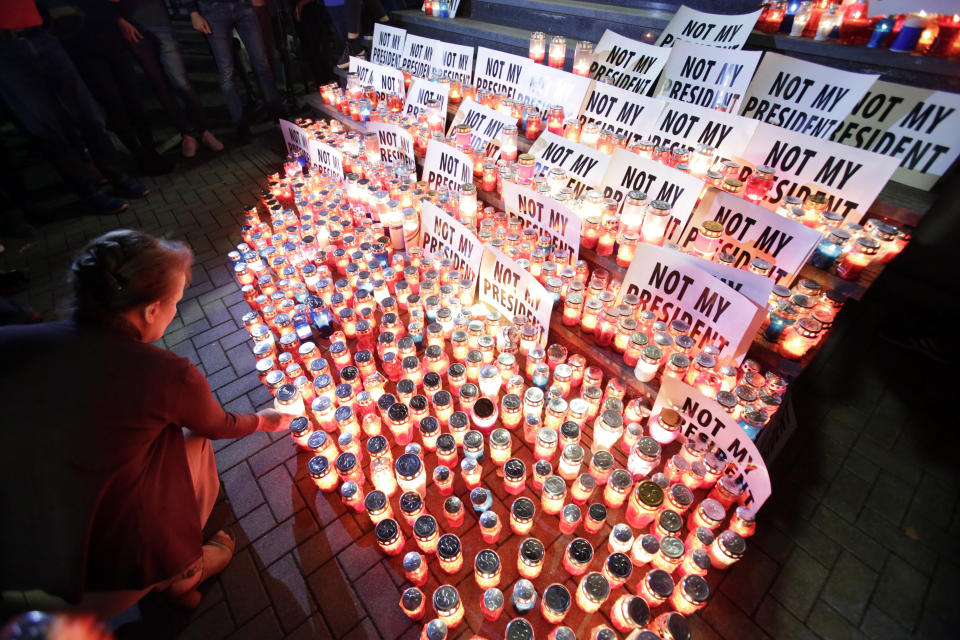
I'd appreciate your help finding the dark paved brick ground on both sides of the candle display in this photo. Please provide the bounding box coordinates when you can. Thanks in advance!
[0,135,960,640]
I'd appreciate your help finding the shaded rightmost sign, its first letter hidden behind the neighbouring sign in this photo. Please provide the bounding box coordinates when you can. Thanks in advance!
[830,81,960,189]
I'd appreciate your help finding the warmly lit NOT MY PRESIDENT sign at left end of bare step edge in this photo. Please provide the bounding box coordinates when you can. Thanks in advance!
[478,245,553,345]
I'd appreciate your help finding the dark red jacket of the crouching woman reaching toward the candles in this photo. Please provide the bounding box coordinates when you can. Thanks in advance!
[0,321,257,601]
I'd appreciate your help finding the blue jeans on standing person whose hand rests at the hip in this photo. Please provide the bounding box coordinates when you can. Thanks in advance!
[197,0,285,124]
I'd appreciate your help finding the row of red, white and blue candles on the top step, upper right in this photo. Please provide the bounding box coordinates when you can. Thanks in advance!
[756,0,960,56]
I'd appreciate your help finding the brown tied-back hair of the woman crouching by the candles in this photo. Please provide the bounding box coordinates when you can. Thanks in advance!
[70,229,193,326]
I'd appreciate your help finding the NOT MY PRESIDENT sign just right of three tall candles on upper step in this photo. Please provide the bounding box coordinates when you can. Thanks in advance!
[590,29,670,95]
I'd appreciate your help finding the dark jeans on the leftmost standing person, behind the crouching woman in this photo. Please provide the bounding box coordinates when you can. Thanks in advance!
[0,32,127,196]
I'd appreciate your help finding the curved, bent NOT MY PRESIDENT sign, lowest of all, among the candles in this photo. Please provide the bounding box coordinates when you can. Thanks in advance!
[650,377,771,511]
